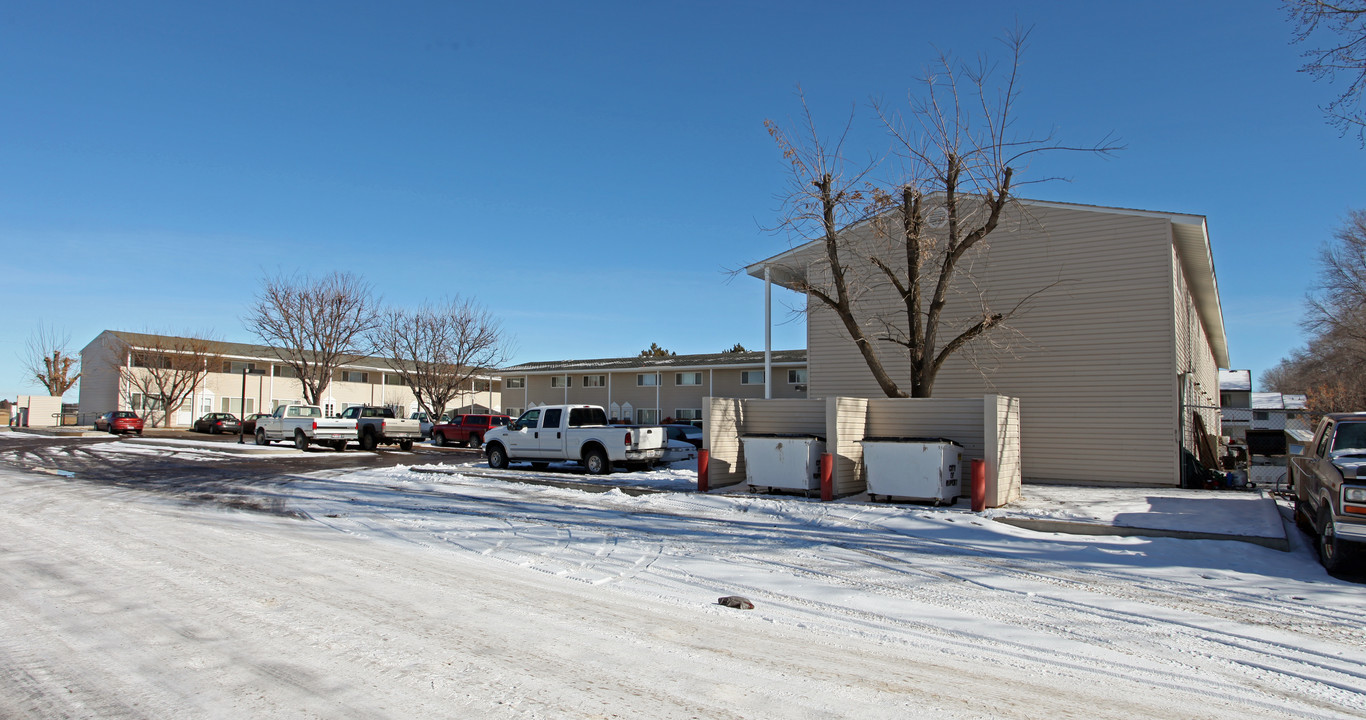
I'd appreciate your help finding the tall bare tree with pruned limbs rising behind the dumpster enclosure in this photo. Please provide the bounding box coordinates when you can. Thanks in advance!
[765,30,1120,398]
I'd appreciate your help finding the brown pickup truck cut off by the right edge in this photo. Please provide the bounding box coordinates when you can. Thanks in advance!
[1290,413,1366,572]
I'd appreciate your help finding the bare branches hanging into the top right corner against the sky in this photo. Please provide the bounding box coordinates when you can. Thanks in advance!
[1285,0,1366,146]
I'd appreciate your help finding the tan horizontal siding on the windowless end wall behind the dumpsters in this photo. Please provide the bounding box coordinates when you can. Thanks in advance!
[807,200,1179,485]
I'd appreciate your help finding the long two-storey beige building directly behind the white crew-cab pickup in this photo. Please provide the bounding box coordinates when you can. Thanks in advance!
[500,350,807,424]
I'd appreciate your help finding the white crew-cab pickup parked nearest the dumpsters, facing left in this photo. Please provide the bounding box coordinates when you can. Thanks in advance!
[484,404,665,475]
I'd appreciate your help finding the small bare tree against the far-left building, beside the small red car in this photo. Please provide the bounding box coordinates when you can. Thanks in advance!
[111,333,223,428]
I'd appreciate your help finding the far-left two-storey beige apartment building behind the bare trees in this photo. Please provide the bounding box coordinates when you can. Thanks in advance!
[79,331,503,426]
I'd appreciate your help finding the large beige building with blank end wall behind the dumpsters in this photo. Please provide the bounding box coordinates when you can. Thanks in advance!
[748,201,1229,485]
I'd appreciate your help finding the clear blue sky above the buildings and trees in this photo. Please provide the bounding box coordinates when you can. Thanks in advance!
[0,1,1366,398]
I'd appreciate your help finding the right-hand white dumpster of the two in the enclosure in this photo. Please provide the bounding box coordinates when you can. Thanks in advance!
[861,437,963,506]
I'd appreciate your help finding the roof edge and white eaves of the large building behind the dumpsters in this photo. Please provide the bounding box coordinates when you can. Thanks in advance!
[744,198,1229,368]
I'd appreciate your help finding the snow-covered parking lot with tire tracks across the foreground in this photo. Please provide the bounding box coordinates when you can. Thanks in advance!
[0,437,1366,717]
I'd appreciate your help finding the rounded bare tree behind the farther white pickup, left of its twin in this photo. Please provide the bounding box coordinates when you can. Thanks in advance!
[243,272,378,404]
